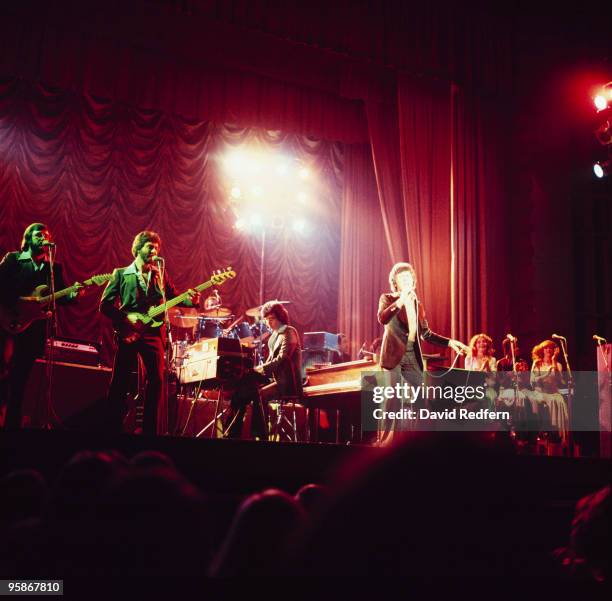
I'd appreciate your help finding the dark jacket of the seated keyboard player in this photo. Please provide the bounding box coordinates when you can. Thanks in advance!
[263,326,302,396]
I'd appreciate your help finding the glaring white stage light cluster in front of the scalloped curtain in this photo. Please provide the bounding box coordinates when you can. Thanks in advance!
[222,148,315,234]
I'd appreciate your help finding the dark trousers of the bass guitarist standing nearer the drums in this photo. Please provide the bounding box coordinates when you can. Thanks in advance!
[108,333,165,435]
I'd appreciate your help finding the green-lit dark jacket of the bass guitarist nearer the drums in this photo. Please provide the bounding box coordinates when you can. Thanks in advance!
[100,263,191,338]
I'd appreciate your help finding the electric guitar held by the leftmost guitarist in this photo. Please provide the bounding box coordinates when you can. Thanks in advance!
[0,273,112,334]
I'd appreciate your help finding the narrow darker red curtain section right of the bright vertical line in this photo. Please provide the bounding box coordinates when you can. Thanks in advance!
[451,86,510,352]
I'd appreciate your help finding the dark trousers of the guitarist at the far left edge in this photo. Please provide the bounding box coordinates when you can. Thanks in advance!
[2,321,46,430]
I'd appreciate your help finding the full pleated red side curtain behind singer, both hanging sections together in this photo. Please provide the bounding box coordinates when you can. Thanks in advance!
[366,76,507,352]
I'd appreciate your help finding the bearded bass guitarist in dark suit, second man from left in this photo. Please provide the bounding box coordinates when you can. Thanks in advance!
[100,231,200,435]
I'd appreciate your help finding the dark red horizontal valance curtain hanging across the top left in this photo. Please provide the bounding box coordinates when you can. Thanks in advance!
[0,3,368,143]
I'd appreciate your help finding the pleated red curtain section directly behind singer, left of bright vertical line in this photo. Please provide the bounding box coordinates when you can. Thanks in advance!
[366,76,451,350]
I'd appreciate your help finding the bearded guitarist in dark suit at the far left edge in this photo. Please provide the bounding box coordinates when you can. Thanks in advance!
[0,223,83,430]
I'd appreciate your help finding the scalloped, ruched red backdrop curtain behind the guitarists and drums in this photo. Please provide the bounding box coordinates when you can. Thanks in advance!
[0,79,341,360]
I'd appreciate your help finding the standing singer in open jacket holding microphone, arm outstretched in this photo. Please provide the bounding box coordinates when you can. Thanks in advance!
[378,263,470,445]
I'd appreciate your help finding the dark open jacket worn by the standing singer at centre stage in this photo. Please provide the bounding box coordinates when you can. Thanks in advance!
[378,293,449,369]
